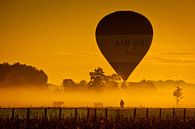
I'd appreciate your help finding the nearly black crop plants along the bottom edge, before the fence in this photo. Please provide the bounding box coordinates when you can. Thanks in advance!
[0,117,195,129]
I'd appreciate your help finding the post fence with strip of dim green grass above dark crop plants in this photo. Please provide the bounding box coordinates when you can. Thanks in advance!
[0,108,195,121]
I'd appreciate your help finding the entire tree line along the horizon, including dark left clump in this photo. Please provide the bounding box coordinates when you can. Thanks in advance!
[0,63,187,89]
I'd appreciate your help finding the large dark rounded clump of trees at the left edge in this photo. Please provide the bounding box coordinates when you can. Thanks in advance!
[0,63,48,85]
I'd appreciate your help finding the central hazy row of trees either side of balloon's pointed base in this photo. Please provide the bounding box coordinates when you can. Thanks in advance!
[62,67,156,89]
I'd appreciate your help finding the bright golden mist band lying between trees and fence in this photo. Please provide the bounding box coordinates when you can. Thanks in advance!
[0,86,195,108]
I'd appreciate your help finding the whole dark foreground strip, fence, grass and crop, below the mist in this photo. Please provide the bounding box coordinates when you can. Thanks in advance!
[0,108,195,129]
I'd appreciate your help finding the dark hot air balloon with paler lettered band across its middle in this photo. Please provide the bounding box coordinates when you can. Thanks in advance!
[96,11,153,81]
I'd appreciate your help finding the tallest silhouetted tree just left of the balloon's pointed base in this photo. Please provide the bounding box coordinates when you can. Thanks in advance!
[88,68,106,88]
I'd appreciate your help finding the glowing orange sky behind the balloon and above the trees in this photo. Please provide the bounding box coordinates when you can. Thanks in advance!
[0,0,195,84]
